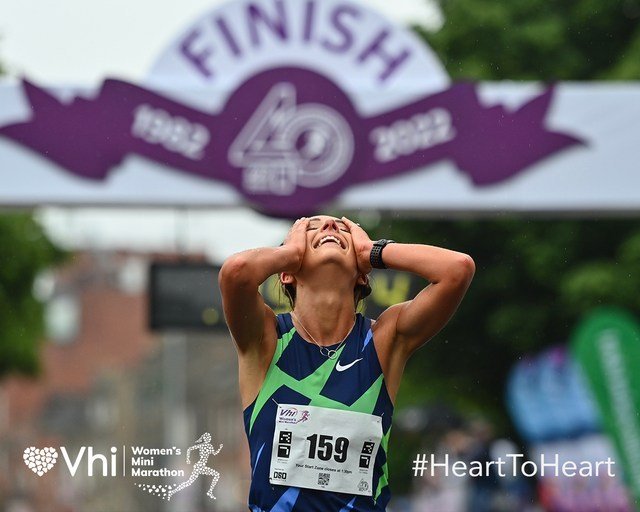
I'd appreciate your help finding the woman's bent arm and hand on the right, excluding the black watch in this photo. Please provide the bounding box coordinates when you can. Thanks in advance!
[344,219,475,357]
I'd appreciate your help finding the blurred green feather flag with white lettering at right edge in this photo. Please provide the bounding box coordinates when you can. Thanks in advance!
[571,308,640,506]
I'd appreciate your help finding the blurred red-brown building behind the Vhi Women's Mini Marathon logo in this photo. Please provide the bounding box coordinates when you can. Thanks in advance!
[0,252,249,512]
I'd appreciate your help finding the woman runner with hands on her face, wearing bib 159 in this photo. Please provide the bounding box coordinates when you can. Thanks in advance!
[219,215,475,512]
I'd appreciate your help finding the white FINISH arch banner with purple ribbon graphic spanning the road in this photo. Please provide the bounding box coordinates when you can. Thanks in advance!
[0,0,640,216]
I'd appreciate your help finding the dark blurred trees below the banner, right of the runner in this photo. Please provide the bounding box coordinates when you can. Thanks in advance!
[370,218,640,492]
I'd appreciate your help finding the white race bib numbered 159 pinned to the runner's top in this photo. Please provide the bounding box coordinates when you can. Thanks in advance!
[269,404,382,496]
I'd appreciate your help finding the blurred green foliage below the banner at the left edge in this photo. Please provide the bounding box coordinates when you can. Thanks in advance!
[0,213,64,378]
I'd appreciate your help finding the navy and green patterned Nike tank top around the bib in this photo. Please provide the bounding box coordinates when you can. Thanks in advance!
[244,313,393,512]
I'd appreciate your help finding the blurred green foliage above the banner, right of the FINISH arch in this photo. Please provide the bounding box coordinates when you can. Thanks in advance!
[416,0,640,81]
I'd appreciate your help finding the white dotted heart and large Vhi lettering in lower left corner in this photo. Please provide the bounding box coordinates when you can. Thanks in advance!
[22,446,118,476]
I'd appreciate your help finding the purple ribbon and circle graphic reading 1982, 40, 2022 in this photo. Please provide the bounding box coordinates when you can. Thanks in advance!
[0,68,584,216]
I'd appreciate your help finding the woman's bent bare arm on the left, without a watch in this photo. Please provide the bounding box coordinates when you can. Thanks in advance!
[218,218,308,353]
